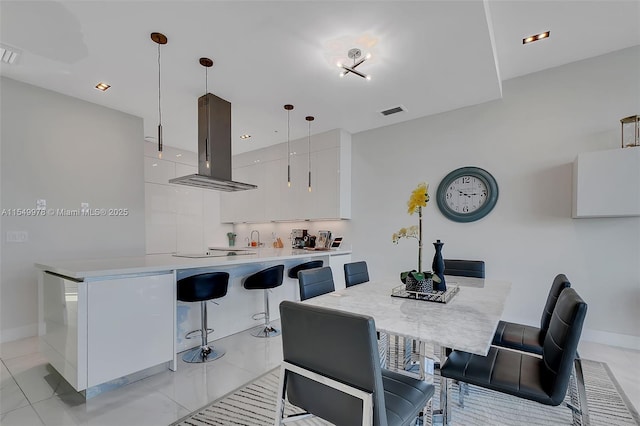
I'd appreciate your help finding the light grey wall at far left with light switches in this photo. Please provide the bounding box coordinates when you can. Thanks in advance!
[0,78,145,341]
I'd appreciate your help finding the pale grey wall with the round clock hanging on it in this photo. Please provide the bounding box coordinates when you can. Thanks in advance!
[349,47,640,347]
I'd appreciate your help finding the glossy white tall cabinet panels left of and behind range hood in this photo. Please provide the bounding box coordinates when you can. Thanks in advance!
[144,142,233,254]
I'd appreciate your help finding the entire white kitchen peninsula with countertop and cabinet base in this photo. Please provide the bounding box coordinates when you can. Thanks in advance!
[35,248,351,398]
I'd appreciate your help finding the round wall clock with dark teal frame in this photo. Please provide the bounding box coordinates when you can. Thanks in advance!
[436,167,498,222]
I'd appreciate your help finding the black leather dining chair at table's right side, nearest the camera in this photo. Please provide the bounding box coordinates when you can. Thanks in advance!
[440,288,587,425]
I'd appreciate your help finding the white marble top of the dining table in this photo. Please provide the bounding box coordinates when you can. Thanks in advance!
[302,276,511,356]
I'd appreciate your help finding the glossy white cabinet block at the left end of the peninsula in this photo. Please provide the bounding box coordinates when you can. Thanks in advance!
[39,271,176,391]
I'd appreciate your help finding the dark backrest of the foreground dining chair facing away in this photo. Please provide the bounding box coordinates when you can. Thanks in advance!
[280,301,387,425]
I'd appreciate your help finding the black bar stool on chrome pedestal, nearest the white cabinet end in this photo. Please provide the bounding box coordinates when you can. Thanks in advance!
[178,272,229,363]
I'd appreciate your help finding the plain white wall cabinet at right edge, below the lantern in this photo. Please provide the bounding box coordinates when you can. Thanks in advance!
[573,148,640,218]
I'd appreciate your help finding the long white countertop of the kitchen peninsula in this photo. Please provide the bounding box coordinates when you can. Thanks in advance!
[35,247,351,280]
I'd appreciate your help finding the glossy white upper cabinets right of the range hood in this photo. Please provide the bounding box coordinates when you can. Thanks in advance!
[220,129,351,223]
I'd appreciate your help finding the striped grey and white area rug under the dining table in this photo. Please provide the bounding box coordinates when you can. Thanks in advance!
[172,360,640,426]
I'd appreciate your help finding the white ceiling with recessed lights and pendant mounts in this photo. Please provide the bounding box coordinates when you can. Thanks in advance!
[0,0,640,154]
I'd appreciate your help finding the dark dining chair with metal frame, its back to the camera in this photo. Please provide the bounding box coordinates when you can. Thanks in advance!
[275,301,434,426]
